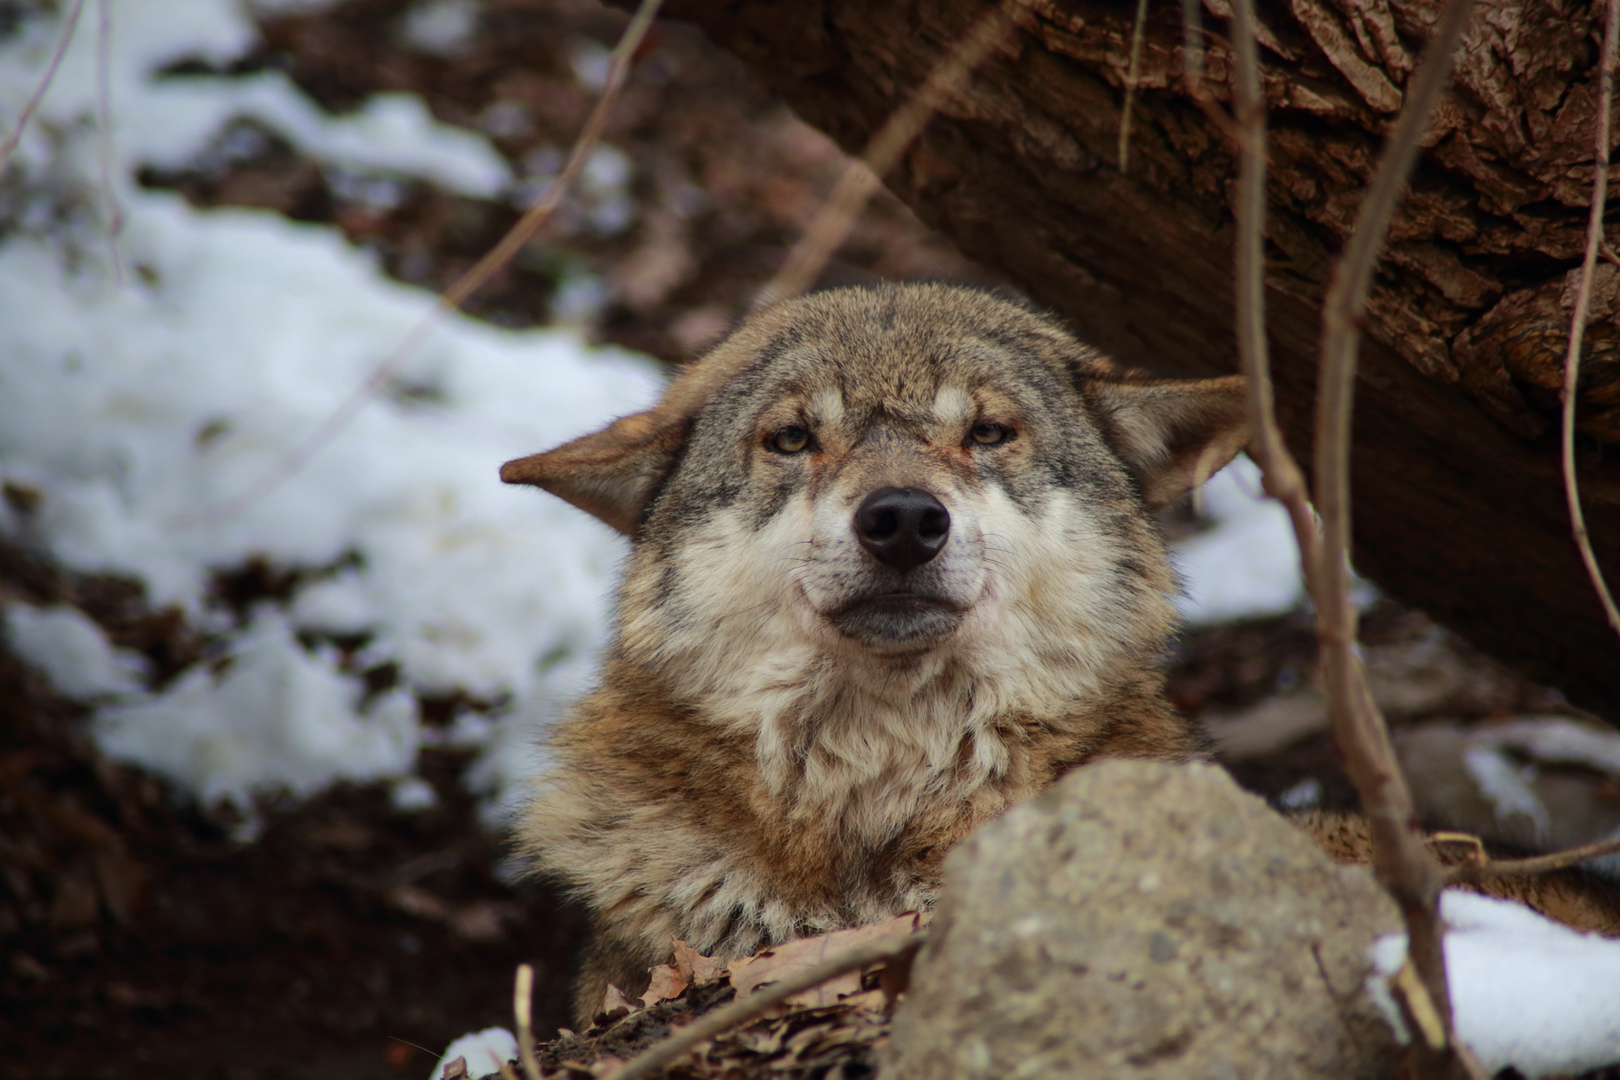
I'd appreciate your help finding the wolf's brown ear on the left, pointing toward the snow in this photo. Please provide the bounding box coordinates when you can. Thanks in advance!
[501,408,690,536]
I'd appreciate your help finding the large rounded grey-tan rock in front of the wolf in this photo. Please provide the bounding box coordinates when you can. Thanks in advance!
[883,761,1400,1080]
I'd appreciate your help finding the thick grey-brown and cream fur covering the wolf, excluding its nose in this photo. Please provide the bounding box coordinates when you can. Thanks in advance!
[502,285,1247,1020]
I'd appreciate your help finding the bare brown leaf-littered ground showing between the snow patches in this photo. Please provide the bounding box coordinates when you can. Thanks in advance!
[0,0,1613,1080]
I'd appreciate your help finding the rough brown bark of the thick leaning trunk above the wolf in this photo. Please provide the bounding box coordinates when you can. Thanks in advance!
[654,0,1620,722]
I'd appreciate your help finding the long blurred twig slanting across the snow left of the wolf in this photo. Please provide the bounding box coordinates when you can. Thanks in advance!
[178,0,663,528]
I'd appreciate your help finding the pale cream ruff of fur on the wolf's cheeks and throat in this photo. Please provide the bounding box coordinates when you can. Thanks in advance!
[620,492,1173,844]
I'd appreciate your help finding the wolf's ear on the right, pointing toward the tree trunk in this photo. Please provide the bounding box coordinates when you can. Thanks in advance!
[1082,376,1249,510]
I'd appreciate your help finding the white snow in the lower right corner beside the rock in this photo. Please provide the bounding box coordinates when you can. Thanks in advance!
[1367,889,1620,1080]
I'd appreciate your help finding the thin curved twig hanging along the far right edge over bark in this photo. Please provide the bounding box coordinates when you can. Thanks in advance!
[1563,0,1620,633]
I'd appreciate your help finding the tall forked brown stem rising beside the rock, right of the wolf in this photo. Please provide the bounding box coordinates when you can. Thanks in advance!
[1233,0,1473,1075]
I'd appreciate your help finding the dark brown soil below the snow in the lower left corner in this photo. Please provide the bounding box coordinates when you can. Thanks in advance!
[0,615,578,1080]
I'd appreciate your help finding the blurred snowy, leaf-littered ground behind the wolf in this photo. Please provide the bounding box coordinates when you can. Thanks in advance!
[0,0,1620,1080]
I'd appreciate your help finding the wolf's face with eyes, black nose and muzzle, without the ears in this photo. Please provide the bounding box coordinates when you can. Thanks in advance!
[642,320,1170,664]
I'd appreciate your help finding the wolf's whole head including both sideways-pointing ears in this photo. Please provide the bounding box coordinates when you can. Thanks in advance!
[501,285,1247,751]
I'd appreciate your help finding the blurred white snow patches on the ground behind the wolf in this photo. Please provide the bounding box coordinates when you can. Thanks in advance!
[0,0,1299,819]
